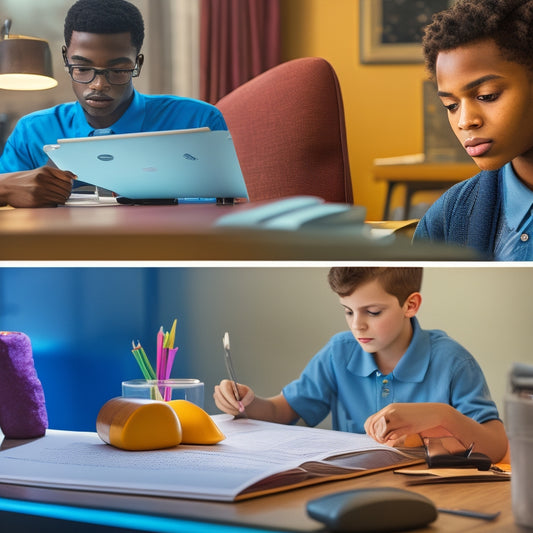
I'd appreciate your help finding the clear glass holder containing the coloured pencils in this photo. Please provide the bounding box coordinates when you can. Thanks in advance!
[122,379,204,409]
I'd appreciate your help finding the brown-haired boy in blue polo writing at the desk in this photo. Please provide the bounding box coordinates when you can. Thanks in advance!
[214,267,507,462]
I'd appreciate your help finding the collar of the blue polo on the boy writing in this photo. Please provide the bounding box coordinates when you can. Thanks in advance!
[348,317,431,383]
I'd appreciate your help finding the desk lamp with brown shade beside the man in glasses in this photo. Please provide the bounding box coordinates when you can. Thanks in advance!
[0,19,57,91]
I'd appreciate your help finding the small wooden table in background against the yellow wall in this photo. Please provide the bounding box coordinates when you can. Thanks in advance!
[373,162,479,220]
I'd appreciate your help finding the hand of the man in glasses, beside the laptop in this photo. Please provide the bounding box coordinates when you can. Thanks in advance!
[0,166,76,207]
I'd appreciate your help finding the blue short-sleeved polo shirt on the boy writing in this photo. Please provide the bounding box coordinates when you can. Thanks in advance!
[282,318,499,433]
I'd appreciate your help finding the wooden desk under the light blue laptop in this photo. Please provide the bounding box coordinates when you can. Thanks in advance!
[0,204,476,261]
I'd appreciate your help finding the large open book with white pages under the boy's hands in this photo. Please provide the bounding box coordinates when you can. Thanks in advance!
[0,415,423,501]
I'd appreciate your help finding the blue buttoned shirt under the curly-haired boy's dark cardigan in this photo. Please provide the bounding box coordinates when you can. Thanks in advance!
[494,163,533,261]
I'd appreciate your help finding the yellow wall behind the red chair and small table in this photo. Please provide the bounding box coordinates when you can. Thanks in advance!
[282,0,426,220]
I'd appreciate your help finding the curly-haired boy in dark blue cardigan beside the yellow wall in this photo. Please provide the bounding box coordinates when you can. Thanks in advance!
[414,0,533,261]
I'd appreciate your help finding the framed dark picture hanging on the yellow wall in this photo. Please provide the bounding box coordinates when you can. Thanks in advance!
[359,0,454,63]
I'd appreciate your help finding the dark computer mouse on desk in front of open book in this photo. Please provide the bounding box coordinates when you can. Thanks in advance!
[307,487,437,532]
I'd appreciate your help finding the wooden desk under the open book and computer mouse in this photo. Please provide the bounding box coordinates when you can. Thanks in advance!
[0,471,516,533]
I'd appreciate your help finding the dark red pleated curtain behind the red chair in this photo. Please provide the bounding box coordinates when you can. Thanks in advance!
[200,0,281,104]
